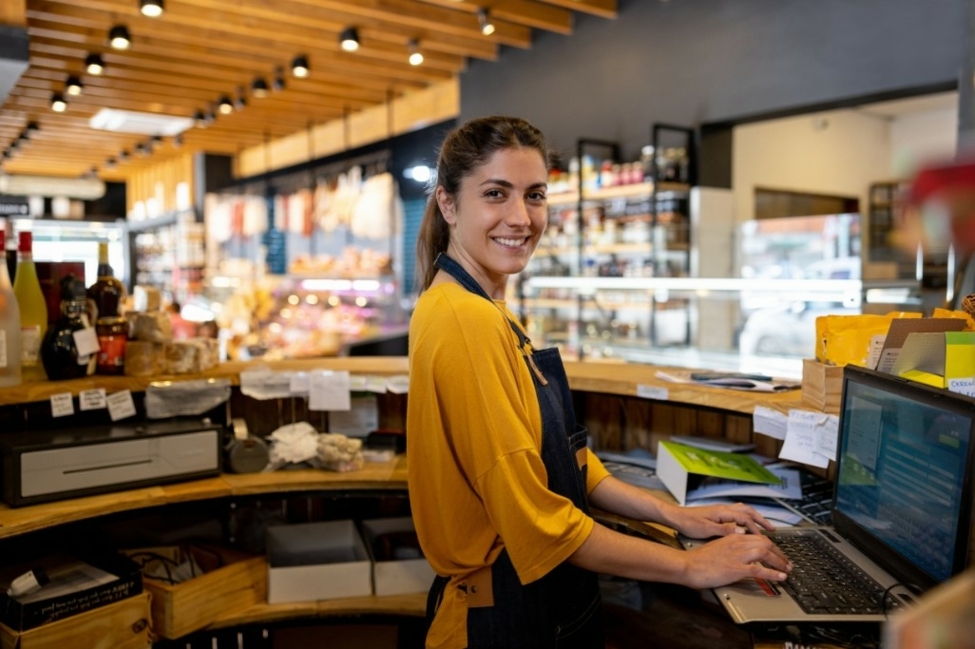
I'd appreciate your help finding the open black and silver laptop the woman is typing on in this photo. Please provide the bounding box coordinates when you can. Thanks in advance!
[681,366,975,623]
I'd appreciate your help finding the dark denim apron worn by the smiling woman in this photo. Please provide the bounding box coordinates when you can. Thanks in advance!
[427,254,604,649]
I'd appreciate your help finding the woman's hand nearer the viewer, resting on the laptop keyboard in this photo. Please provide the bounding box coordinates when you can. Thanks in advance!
[684,534,792,588]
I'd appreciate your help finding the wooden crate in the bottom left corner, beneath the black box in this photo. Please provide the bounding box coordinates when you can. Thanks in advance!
[0,592,152,649]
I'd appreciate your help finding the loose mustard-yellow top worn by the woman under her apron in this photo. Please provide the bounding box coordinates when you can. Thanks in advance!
[407,283,609,649]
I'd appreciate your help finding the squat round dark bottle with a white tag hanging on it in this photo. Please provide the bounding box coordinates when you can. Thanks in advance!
[40,271,98,381]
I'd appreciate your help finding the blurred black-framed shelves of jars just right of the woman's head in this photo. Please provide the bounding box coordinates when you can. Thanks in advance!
[512,125,693,359]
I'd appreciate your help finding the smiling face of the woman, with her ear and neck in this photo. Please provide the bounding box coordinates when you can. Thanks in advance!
[437,147,548,299]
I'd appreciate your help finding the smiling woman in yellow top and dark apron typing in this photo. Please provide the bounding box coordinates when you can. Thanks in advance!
[407,117,790,649]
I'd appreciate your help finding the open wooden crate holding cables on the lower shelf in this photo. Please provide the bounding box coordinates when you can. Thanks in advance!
[143,548,267,638]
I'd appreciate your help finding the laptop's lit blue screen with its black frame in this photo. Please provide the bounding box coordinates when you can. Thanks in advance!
[834,368,975,588]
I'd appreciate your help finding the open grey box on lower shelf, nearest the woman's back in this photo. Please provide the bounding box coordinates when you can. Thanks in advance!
[362,516,435,595]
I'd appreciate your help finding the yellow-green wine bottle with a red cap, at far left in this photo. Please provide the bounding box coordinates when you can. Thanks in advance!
[14,232,47,382]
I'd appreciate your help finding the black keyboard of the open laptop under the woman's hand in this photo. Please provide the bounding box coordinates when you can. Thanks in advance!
[769,532,899,615]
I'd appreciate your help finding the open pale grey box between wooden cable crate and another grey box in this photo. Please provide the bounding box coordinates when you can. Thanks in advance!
[267,520,372,604]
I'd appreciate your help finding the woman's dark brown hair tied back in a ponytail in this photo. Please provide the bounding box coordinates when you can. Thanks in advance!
[416,116,549,292]
